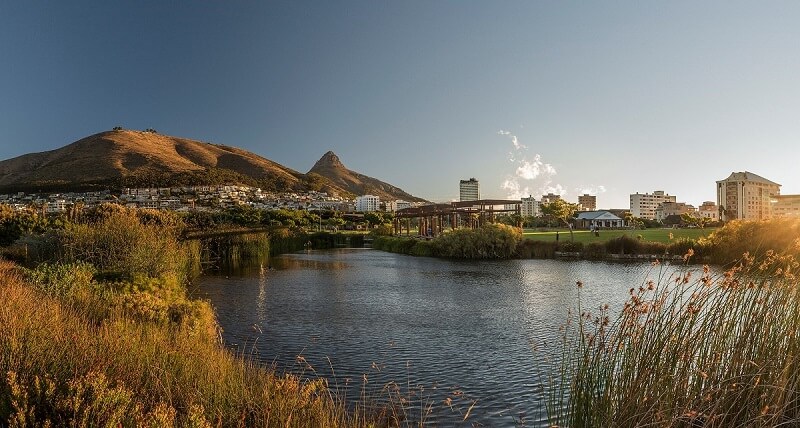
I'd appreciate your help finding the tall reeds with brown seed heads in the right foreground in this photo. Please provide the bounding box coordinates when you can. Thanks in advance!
[549,246,800,427]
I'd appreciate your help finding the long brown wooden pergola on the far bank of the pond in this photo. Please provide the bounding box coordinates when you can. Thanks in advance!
[392,199,522,237]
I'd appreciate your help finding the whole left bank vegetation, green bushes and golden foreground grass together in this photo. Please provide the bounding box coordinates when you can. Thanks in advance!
[0,206,382,427]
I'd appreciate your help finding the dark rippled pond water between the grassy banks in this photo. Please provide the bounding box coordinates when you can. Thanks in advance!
[197,249,700,426]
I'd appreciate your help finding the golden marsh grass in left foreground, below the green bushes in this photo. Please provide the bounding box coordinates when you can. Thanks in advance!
[0,262,365,427]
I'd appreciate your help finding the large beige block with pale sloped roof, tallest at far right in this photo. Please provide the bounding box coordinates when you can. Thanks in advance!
[717,171,781,221]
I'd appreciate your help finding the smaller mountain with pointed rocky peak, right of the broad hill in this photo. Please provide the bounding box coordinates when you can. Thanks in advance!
[308,151,424,202]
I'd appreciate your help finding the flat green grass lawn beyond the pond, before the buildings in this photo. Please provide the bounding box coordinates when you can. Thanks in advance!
[523,227,716,244]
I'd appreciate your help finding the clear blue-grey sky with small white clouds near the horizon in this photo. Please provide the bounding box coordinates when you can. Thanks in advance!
[0,0,800,208]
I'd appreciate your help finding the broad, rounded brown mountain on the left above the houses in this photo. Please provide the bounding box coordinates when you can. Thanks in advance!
[0,129,418,200]
